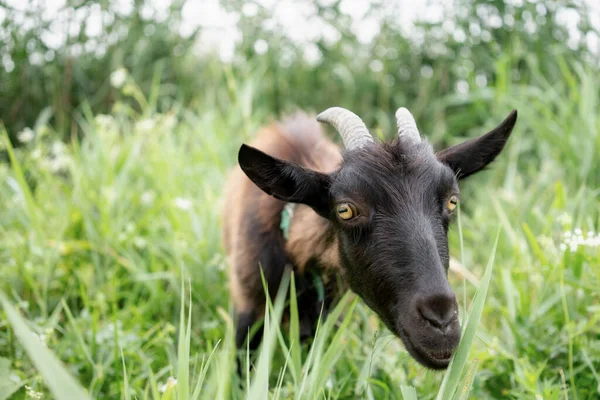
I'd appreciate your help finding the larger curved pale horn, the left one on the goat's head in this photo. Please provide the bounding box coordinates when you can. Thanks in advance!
[317,107,374,150]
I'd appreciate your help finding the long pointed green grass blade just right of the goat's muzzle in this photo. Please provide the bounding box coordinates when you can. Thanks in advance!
[436,231,500,400]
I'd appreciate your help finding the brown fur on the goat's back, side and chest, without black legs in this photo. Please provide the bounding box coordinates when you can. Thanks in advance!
[223,113,342,314]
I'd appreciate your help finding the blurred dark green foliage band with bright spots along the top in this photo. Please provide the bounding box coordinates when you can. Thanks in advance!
[0,0,598,140]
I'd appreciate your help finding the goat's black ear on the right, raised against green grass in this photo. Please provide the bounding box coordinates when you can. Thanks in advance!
[437,110,517,179]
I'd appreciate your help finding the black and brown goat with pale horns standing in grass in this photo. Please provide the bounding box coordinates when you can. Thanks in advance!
[223,107,517,369]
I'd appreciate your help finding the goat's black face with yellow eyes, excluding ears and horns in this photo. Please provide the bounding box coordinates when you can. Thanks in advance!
[329,143,460,368]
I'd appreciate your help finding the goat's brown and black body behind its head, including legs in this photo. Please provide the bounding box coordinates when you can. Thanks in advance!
[223,113,342,347]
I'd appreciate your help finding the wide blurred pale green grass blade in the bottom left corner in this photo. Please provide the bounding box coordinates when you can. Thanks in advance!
[0,292,91,400]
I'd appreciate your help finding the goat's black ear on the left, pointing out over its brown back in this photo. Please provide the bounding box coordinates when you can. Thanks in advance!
[238,144,331,216]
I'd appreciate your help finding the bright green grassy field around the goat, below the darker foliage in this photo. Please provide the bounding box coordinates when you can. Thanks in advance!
[0,61,600,400]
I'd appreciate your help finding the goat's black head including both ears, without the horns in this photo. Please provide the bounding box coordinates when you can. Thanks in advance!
[239,111,516,369]
